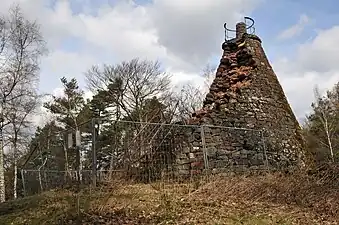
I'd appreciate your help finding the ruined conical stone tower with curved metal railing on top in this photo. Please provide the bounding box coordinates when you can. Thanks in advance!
[177,17,304,175]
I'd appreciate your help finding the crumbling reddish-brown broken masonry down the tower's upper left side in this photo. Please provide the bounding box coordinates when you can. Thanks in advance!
[189,36,256,124]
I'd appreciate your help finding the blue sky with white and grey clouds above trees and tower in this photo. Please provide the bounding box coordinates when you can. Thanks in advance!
[0,0,339,125]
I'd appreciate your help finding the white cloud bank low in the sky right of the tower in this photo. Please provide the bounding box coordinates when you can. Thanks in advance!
[273,26,339,120]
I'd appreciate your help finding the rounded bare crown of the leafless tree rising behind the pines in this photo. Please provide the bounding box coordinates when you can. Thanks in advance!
[85,59,170,122]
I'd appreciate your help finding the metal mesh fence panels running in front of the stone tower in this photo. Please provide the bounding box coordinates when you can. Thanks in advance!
[21,119,270,195]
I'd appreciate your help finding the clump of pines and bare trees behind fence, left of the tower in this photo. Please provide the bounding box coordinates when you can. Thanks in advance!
[21,59,183,186]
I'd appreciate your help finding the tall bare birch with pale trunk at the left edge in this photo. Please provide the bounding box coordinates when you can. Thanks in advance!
[0,5,47,201]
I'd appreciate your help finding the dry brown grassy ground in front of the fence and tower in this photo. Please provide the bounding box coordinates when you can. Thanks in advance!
[0,172,339,225]
